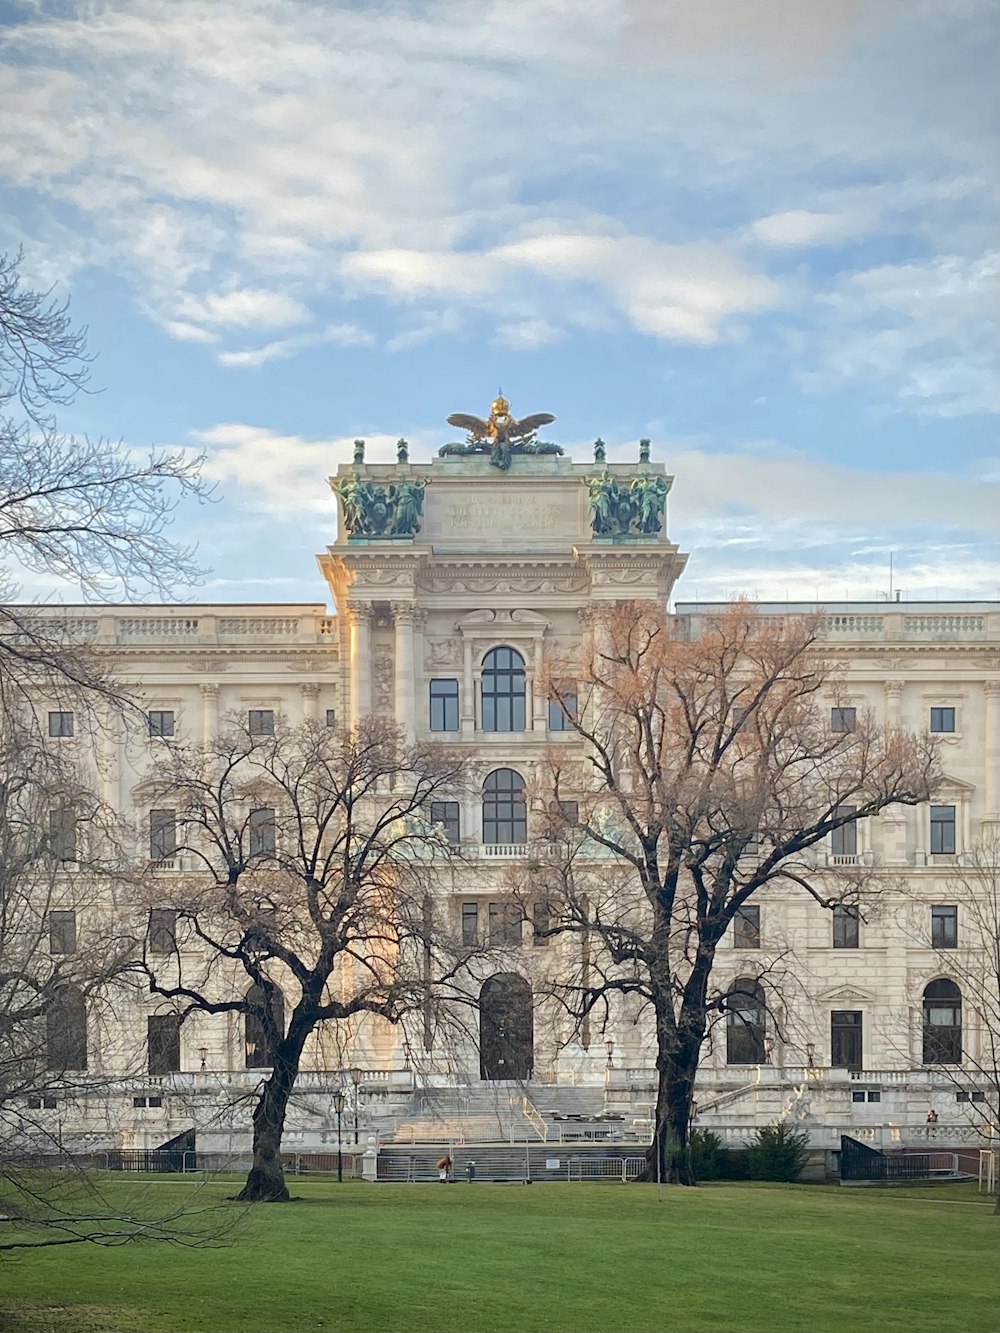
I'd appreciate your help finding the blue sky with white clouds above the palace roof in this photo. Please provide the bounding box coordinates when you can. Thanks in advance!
[0,0,1000,601]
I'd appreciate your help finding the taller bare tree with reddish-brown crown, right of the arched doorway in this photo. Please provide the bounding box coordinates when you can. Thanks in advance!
[532,604,937,1184]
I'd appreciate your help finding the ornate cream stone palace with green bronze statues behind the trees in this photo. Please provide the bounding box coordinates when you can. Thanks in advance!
[23,405,1000,1146]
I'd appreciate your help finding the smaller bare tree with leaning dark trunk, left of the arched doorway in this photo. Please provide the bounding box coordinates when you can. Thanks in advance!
[145,718,474,1201]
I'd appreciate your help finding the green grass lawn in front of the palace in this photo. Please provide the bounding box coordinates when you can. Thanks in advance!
[0,1177,1000,1333]
